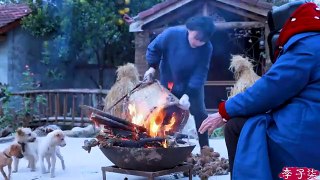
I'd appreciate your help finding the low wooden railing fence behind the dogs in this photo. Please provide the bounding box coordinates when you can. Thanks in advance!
[12,89,108,127]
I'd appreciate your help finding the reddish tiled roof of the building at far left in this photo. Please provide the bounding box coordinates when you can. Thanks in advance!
[0,4,31,28]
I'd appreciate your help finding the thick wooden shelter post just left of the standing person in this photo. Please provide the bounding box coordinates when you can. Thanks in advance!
[134,32,150,76]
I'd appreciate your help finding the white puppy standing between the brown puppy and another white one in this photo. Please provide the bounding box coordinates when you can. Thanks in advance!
[12,128,38,172]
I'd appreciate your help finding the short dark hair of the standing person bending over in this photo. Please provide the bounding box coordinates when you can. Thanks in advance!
[186,16,215,42]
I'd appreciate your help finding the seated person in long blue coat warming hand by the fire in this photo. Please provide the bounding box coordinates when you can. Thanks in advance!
[199,3,320,180]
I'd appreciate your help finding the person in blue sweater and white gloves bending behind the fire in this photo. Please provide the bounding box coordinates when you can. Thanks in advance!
[144,16,215,147]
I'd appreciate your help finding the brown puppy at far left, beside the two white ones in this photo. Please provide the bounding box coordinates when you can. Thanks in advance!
[0,143,23,180]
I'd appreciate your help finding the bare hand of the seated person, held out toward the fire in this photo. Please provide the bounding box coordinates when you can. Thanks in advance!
[198,112,225,135]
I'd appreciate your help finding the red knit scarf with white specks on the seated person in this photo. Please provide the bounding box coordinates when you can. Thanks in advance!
[274,3,320,60]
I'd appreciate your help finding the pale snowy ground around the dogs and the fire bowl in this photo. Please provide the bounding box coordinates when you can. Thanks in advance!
[0,138,230,180]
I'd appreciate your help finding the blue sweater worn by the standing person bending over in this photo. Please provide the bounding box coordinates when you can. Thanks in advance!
[146,27,212,95]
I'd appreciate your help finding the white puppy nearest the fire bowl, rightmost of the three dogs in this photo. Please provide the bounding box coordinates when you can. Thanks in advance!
[39,130,66,178]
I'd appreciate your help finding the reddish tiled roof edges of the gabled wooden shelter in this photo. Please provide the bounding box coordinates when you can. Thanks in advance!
[138,0,272,20]
